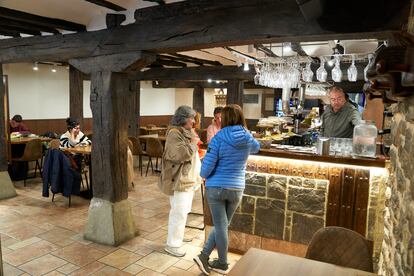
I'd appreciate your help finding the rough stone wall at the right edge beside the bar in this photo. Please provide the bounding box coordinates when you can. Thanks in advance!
[379,97,414,275]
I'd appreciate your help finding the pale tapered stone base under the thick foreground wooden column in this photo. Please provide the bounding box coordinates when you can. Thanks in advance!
[84,197,138,246]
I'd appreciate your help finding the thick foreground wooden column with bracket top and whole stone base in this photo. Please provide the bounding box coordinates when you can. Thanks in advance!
[69,51,153,246]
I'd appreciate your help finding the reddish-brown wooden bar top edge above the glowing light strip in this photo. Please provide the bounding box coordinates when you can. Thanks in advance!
[255,149,388,168]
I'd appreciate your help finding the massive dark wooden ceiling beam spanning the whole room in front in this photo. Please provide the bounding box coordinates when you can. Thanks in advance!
[0,0,406,63]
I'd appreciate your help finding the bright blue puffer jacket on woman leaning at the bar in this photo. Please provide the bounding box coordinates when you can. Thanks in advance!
[200,125,260,189]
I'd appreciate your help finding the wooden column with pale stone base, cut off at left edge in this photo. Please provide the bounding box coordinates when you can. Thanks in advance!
[0,64,17,198]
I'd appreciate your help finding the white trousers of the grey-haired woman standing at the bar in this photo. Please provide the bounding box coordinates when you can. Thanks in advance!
[167,189,194,247]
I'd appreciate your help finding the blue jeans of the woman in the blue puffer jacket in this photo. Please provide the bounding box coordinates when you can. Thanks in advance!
[201,187,243,264]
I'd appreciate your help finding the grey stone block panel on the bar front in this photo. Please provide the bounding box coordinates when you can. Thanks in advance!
[229,172,329,244]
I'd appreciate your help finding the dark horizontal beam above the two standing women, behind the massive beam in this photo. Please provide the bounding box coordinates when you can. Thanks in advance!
[130,66,256,81]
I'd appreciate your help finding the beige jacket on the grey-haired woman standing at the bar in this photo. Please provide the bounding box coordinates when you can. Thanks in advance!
[158,127,197,195]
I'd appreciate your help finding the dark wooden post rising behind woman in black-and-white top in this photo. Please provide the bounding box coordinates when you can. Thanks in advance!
[69,65,84,126]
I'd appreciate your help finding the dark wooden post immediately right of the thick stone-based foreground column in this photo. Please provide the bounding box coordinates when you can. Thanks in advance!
[128,80,141,137]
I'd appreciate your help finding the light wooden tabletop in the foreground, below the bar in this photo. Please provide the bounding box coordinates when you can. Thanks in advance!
[227,248,376,276]
